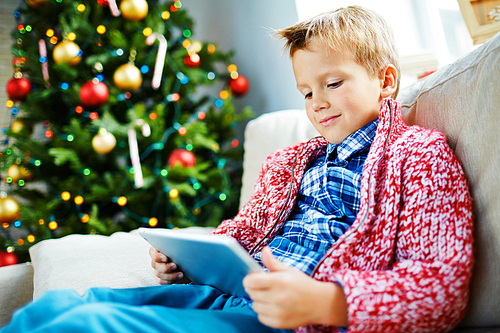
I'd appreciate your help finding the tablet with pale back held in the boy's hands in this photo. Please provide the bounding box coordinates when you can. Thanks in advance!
[139,228,263,298]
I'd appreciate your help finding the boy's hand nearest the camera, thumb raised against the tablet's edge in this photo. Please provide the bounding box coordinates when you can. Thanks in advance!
[243,247,347,329]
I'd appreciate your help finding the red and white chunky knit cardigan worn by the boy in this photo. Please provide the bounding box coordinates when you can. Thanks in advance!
[215,99,473,333]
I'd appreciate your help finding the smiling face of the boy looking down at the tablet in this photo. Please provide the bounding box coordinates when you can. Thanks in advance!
[292,42,383,144]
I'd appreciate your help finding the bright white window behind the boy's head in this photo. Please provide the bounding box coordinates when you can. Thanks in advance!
[295,0,473,88]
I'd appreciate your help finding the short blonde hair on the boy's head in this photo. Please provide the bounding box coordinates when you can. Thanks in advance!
[276,6,400,98]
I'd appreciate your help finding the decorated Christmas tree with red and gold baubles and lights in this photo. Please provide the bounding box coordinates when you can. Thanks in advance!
[0,0,251,266]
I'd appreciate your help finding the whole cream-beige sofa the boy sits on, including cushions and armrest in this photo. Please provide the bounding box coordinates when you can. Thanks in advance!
[0,34,500,333]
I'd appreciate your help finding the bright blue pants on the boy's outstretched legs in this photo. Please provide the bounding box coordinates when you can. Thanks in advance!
[0,285,291,333]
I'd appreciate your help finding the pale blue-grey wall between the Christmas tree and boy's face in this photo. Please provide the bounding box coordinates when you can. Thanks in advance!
[182,0,304,115]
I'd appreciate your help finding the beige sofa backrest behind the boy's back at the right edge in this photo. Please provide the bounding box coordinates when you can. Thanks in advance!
[400,34,500,327]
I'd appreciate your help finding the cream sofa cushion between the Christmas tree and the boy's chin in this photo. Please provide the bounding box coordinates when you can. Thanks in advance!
[240,110,319,207]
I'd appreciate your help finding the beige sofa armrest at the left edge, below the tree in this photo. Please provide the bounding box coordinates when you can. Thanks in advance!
[0,264,33,327]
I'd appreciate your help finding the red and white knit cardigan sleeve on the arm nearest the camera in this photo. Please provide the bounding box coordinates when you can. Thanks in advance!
[312,134,473,333]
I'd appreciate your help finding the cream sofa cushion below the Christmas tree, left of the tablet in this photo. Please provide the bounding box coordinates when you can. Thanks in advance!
[30,228,157,299]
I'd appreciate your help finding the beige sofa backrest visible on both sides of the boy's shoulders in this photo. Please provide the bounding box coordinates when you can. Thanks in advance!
[240,34,500,327]
